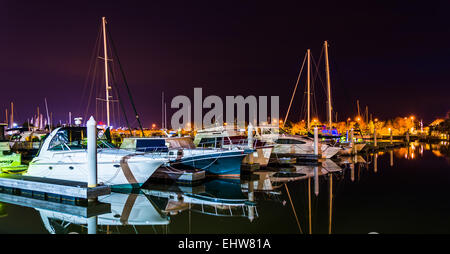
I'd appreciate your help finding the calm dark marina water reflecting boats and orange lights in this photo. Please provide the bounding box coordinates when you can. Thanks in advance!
[0,144,450,234]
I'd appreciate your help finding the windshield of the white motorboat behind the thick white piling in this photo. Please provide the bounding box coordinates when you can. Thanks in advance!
[48,127,114,151]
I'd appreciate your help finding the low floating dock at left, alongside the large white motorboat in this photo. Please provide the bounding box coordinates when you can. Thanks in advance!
[0,173,111,202]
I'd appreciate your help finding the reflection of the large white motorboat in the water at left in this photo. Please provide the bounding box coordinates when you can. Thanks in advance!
[36,192,170,234]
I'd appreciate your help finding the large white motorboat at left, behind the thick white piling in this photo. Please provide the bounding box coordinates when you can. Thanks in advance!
[25,127,168,188]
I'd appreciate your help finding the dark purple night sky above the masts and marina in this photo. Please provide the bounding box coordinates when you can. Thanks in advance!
[0,0,450,127]
